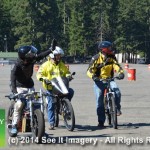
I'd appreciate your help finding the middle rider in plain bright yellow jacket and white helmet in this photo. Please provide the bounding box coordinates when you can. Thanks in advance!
[37,46,74,130]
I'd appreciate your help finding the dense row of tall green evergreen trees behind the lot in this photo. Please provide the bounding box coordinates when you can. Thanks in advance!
[0,0,150,62]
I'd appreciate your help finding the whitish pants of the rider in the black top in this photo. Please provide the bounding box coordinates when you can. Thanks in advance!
[12,87,34,125]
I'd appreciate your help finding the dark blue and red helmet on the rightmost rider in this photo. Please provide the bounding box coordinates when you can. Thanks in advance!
[98,41,114,55]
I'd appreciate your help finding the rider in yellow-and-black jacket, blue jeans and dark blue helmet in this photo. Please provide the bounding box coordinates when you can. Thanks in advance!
[87,41,124,127]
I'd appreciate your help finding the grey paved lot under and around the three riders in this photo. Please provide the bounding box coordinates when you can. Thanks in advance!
[0,64,150,150]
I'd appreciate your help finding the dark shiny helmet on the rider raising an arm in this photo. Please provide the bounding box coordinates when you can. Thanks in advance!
[18,46,38,60]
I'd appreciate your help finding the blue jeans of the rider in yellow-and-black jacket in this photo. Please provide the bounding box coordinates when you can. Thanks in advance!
[94,81,121,123]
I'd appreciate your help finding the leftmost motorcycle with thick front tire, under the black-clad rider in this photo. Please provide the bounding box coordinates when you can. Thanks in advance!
[5,91,45,143]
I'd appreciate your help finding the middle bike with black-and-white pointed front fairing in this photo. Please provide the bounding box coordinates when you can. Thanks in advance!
[43,72,75,131]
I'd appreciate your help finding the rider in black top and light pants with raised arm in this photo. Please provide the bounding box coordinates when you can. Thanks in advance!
[11,41,56,134]
